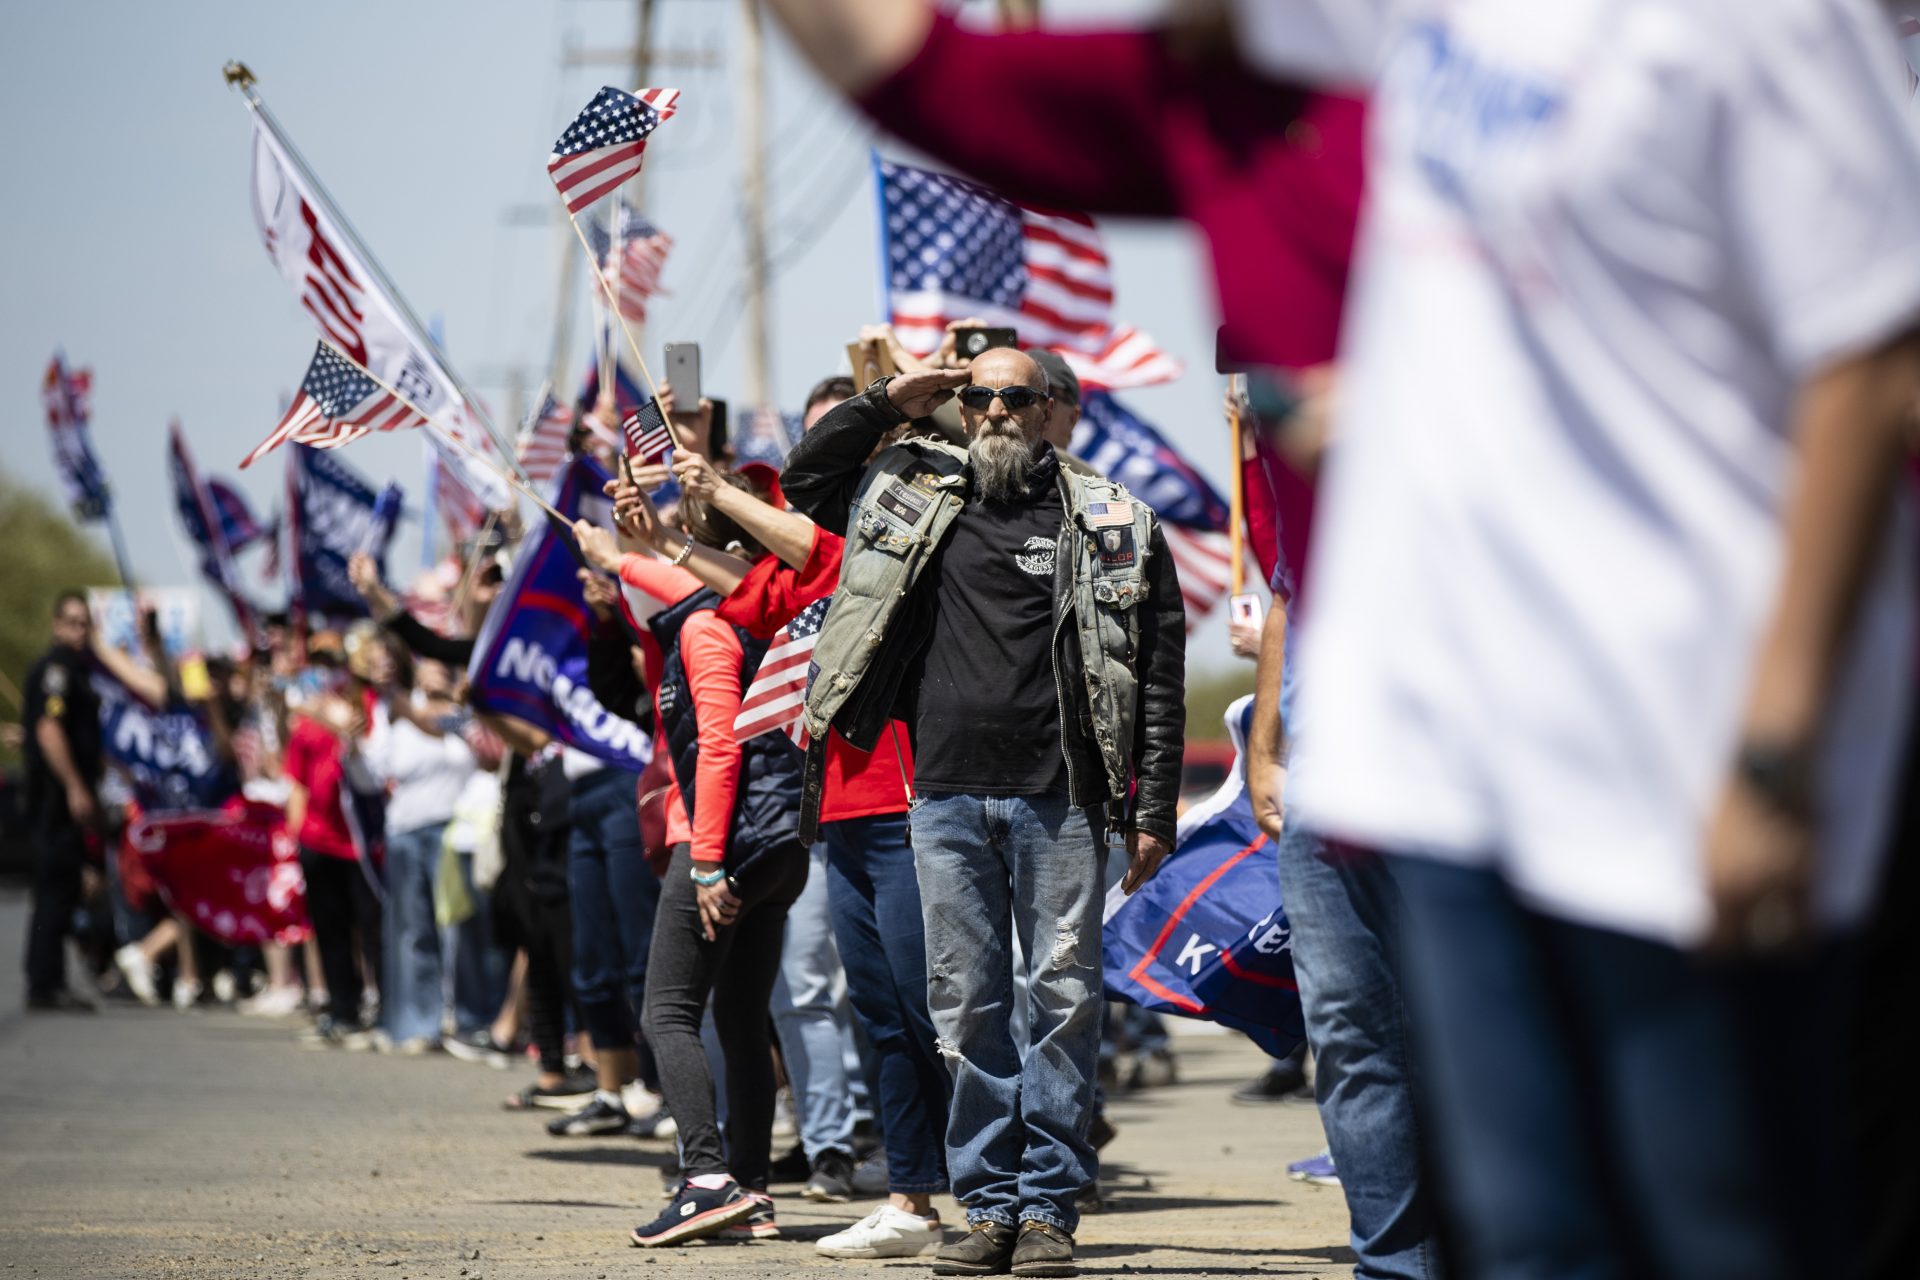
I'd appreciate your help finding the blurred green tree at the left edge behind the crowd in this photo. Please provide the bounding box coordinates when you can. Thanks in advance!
[0,472,119,762]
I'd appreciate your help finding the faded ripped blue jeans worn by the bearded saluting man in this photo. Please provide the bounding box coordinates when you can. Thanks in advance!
[912,791,1102,1232]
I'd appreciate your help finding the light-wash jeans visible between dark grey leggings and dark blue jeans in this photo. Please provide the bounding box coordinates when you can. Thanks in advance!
[774,842,852,1159]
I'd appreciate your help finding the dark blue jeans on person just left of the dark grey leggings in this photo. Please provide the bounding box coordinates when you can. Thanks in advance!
[566,770,660,1050]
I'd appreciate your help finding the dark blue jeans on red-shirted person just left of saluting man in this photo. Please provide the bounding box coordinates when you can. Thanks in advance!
[821,814,950,1194]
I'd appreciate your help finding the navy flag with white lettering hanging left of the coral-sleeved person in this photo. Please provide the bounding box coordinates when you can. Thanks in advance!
[467,457,653,773]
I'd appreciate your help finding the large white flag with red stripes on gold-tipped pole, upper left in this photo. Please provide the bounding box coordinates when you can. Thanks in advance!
[248,101,515,509]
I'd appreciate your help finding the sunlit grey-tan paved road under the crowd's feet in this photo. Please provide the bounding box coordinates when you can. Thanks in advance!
[0,890,1352,1280]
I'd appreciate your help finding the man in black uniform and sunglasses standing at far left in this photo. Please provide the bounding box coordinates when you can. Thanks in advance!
[23,591,102,1013]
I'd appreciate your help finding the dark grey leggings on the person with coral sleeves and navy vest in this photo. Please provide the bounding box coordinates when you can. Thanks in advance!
[645,842,808,1188]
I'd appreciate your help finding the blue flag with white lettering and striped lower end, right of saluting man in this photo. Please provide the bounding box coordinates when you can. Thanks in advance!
[1068,391,1233,629]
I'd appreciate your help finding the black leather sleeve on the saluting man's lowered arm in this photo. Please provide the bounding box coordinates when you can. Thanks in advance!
[1133,522,1187,844]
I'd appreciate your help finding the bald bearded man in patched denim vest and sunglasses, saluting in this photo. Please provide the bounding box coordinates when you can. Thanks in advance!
[781,349,1187,1276]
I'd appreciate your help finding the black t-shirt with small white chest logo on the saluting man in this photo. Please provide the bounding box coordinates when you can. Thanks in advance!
[914,449,1066,796]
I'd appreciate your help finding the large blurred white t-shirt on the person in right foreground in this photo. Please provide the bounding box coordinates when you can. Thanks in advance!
[1242,0,1920,944]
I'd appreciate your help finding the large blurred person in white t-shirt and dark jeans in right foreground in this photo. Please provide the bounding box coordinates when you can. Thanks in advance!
[1240,0,1920,1278]
